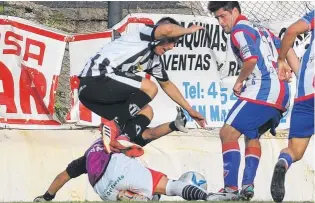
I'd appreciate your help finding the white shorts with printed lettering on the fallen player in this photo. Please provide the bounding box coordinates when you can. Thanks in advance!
[94,154,165,201]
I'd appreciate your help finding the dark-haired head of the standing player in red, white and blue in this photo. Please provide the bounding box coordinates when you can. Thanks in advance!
[208,1,241,33]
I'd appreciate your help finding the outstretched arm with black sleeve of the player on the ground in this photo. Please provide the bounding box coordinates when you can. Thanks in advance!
[34,156,86,202]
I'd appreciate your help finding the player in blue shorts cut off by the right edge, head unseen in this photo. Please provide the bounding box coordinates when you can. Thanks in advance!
[270,10,315,202]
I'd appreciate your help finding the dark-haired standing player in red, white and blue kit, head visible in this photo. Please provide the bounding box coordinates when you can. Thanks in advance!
[208,1,294,200]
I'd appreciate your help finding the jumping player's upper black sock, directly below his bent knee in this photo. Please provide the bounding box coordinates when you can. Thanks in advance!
[117,90,152,126]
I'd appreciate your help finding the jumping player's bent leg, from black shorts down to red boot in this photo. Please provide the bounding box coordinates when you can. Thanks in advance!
[79,73,157,140]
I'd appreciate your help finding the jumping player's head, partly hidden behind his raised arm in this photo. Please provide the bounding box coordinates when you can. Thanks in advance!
[153,17,180,55]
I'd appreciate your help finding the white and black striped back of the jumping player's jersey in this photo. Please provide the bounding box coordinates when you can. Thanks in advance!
[79,26,153,77]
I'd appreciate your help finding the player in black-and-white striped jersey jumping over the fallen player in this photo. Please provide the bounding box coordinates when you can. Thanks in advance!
[79,17,206,156]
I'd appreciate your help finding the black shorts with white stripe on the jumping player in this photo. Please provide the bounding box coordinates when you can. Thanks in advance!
[79,72,143,120]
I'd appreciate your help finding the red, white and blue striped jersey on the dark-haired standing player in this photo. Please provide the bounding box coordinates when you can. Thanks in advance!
[231,19,290,110]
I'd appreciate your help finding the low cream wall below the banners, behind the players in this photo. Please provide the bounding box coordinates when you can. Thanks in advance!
[0,130,314,202]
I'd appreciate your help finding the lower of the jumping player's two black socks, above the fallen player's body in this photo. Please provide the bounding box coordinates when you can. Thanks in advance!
[122,114,151,141]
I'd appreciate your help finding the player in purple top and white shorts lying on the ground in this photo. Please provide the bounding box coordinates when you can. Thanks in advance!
[34,138,217,202]
